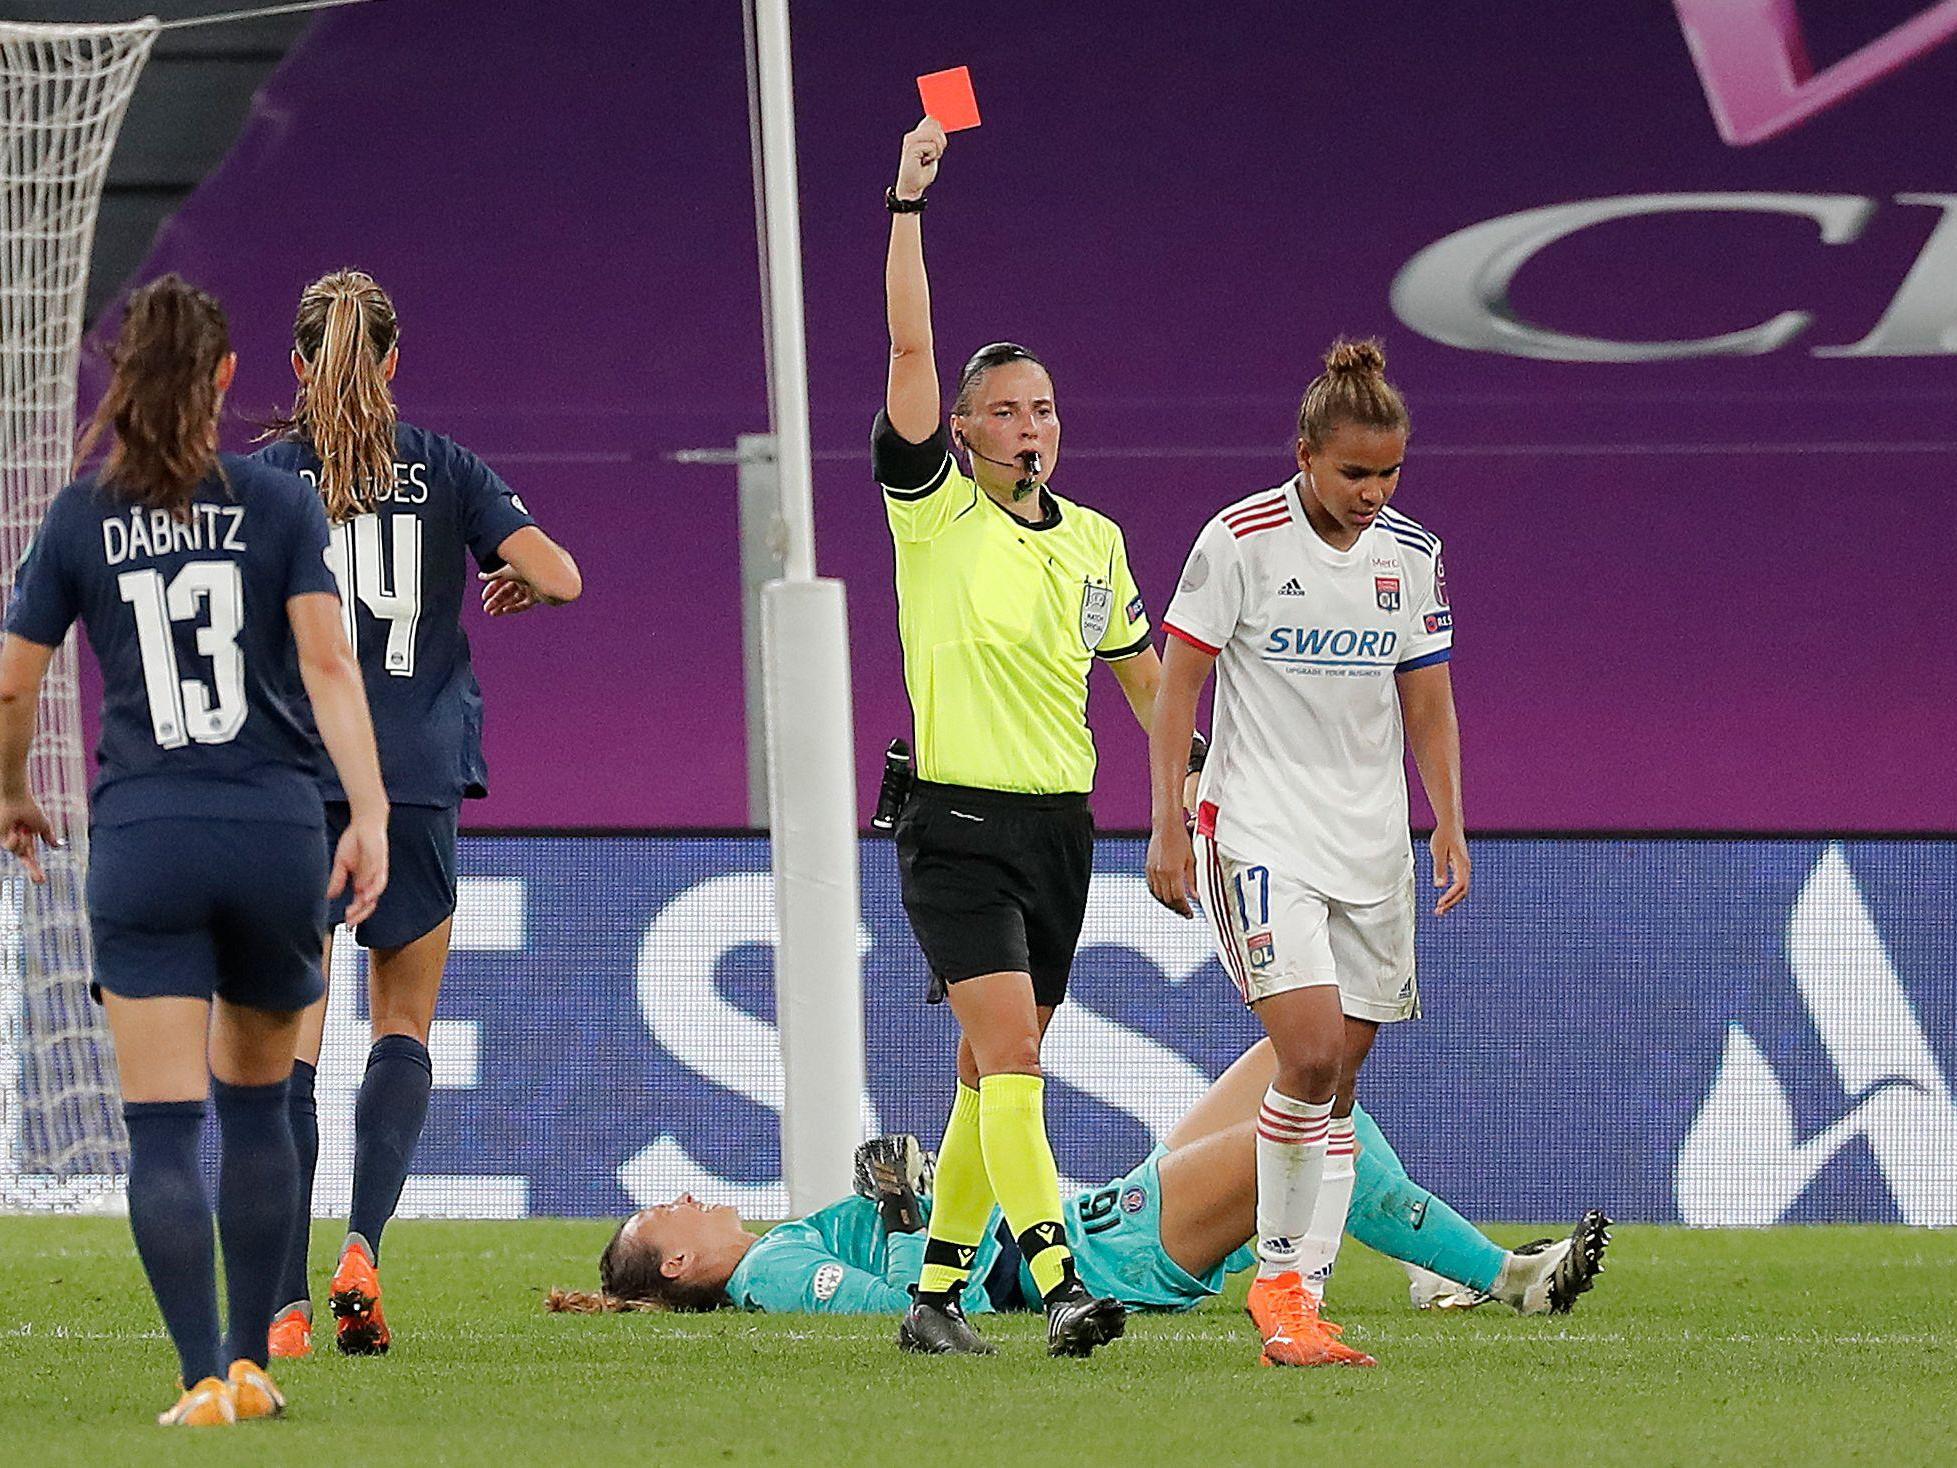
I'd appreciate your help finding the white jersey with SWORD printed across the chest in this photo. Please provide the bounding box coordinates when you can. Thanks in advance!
[1164,480,1454,902]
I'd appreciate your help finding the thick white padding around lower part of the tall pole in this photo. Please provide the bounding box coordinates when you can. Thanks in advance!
[761,579,863,1217]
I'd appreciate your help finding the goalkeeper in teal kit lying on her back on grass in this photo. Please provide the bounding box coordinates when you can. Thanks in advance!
[546,1041,1611,1315]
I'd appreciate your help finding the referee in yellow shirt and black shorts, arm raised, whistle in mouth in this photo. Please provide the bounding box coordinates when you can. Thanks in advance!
[871,117,1162,1356]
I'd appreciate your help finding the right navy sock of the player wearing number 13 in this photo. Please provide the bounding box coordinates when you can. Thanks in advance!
[211,1080,299,1366]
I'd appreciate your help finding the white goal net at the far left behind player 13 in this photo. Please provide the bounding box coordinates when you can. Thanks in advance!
[0,20,159,1210]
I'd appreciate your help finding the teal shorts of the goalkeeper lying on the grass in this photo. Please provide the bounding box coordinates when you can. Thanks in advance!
[1020,1147,1256,1309]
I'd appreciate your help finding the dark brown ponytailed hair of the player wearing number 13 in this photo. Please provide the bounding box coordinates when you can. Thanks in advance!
[74,274,231,515]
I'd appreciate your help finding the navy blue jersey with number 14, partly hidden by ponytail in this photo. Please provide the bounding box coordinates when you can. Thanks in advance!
[256,423,534,806]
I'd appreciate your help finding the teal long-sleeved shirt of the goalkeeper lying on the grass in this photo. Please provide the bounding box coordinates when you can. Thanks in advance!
[728,1198,1018,1315]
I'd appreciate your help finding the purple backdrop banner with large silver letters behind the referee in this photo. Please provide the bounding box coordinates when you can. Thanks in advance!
[107,0,1957,832]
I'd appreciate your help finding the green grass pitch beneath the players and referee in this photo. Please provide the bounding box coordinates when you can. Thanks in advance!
[0,1217,1957,1468]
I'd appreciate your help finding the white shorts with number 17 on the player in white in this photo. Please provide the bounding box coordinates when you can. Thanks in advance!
[1196,836,1421,1024]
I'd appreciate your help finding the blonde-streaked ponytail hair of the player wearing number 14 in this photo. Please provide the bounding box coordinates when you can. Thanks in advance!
[266,270,401,525]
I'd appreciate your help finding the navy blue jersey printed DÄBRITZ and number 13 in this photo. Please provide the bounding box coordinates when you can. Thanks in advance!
[6,454,339,826]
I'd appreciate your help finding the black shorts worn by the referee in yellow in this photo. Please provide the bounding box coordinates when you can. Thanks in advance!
[896,779,1094,1004]
